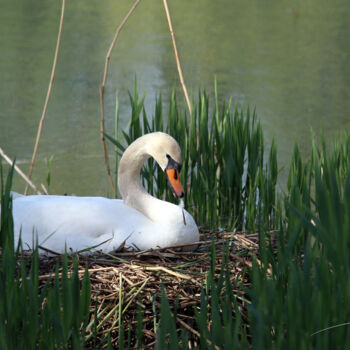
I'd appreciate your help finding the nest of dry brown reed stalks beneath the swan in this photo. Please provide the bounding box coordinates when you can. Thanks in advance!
[34,229,266,349]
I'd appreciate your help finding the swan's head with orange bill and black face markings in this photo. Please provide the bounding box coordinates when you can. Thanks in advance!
[148,132,184,198]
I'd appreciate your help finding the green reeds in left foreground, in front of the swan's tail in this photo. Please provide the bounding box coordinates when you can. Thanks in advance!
[0,163,91,349]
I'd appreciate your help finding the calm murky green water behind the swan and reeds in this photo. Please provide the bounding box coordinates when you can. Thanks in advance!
[0,0,350,195]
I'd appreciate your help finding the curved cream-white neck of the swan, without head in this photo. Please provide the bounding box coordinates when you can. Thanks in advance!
[118,139,170,221]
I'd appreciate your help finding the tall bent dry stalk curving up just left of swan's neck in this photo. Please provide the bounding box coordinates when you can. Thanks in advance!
[100,0,141,193]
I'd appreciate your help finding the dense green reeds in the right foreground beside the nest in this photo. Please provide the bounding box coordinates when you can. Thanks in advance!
[160,136,350,350]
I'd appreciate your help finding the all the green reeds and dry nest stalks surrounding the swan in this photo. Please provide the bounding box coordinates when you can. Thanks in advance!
[0,89,350,349]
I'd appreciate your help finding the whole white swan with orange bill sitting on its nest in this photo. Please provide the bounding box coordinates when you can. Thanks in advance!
[13,132,199,253]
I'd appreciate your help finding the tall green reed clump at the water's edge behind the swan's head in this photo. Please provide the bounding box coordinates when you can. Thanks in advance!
[106,84,278,229]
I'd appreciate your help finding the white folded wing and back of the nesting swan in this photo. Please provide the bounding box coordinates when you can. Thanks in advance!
[13,196,147,252]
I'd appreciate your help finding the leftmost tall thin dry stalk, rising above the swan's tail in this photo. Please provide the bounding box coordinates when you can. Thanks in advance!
[24,0,66,195]
